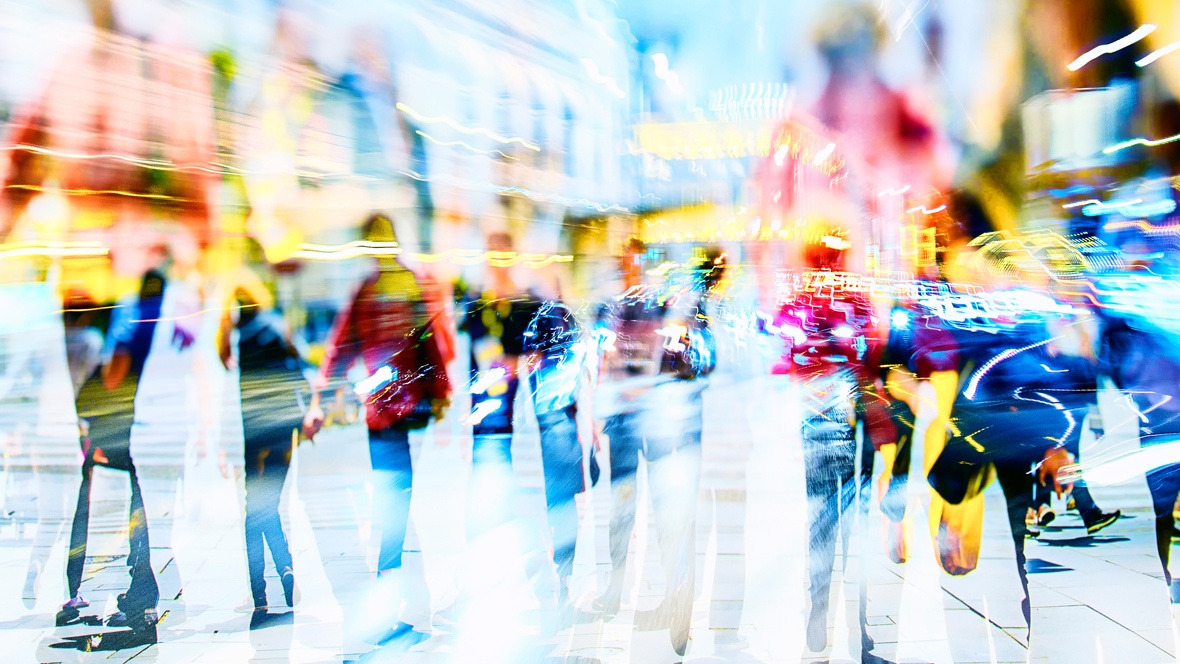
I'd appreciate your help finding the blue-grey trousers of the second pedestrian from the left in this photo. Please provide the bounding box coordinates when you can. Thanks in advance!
[245,428,291,606]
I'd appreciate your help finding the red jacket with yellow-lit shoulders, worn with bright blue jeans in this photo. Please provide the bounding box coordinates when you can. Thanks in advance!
[315,269,451,430]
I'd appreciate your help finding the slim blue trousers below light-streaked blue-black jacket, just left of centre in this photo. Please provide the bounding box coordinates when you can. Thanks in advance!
[537,408,584,577]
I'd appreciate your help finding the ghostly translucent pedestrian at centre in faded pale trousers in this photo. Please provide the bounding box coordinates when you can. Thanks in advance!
[594,238,721,655]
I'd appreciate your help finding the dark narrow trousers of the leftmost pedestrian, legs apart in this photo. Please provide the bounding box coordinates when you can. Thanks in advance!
[66,413,159,616]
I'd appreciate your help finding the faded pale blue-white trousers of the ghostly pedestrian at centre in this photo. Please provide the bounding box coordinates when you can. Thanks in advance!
[604,412,701,619]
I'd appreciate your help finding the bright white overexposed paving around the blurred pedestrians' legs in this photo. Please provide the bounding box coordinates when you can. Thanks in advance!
[0,309,1178,664]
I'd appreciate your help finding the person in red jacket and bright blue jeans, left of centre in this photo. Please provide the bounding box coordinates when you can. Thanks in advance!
[303,215,451,635]
